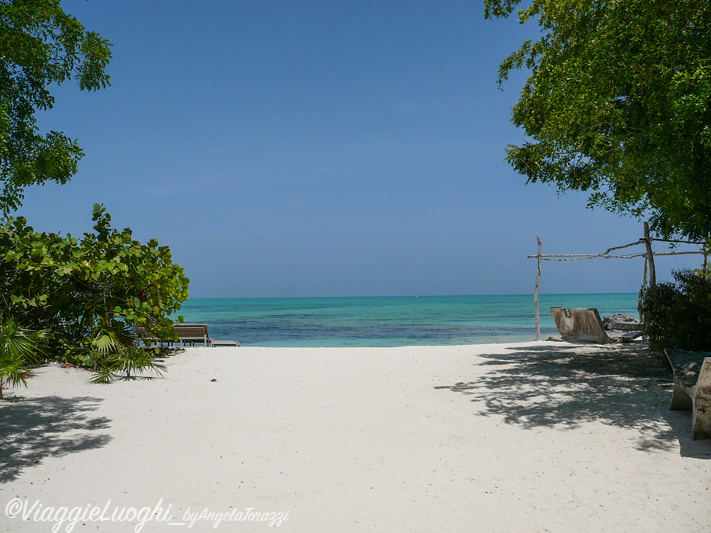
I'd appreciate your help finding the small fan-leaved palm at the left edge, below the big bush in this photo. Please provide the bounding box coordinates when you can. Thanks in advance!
[0,317,47,400]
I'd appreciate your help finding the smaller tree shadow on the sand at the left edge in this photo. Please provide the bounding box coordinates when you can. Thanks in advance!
[0,396,111,483]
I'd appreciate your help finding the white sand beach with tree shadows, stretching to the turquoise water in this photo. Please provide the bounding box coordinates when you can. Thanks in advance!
[0,342,711,532]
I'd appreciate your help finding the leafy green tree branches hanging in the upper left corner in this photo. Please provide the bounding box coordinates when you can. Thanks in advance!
[0,0,111,215]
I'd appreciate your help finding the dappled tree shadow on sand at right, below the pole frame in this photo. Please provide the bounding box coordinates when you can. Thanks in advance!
[436,344,711,459]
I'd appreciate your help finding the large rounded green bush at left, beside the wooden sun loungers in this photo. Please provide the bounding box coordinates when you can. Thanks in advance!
[0,205,189,367]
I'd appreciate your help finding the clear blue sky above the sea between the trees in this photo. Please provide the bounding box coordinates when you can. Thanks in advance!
[19,0,700,297]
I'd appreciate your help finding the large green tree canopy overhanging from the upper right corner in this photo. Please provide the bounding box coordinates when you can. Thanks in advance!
[485,0,711,240]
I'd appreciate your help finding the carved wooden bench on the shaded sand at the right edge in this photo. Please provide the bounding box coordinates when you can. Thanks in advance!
[664,350,711,440]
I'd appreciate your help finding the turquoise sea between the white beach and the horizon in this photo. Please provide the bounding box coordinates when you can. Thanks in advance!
[179,294,637,347]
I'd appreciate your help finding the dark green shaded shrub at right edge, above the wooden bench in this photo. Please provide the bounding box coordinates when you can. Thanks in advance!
[642,270,711,353]
